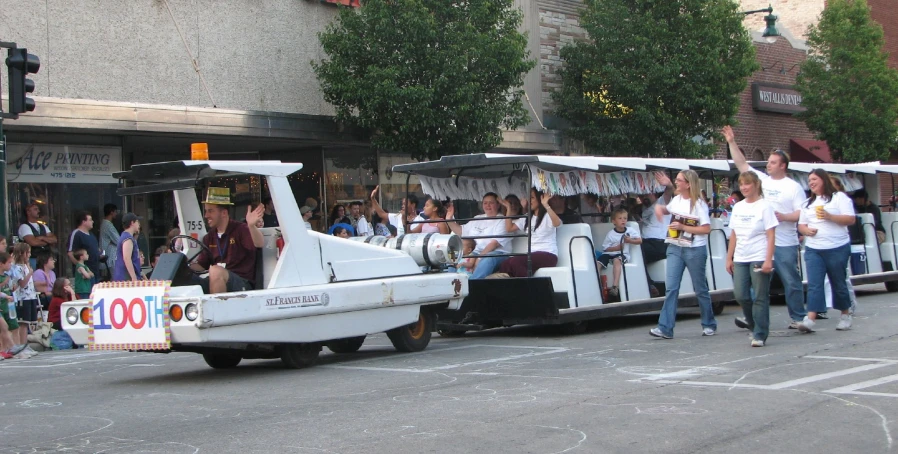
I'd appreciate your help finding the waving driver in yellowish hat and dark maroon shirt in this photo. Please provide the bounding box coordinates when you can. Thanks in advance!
[190,188,265,293]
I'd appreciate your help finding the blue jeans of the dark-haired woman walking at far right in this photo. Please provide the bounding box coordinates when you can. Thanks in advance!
[804,243,851,312]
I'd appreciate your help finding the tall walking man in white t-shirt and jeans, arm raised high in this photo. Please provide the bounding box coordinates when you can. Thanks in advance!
[722,126,807,329]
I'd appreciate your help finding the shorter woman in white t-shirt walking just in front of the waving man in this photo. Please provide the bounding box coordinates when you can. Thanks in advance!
[726,172,779,347]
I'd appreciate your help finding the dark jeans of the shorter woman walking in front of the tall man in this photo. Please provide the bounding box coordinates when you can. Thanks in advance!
[733,262,771,341]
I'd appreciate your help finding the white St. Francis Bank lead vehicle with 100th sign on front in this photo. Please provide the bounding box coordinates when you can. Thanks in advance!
[62,161,468,368]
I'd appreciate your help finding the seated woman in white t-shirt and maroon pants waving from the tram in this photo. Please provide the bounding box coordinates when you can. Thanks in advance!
[499,189,561,277]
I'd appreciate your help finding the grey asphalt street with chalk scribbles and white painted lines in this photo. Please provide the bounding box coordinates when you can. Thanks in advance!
[0,285,898,454]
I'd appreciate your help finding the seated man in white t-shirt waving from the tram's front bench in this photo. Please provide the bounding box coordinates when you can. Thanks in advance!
[446,192,511,279]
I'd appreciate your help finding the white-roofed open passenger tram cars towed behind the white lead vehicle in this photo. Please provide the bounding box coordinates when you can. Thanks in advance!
[393,154,898,336]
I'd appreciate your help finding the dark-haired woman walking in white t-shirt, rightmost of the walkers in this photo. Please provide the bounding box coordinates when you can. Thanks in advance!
[798,169,855,333]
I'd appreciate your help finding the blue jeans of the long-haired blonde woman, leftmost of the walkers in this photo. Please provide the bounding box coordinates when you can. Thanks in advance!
[658,244,717,337]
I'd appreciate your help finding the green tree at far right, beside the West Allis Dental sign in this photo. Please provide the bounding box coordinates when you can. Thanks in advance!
[796,0,898,162]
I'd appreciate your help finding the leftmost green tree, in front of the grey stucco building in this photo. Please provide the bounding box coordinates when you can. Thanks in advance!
[312,0,534,160]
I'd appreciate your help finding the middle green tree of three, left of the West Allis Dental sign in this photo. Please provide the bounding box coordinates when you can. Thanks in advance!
[553,0,759,157]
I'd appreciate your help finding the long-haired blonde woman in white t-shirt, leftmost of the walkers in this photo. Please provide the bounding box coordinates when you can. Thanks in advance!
[649,170,717,339]
